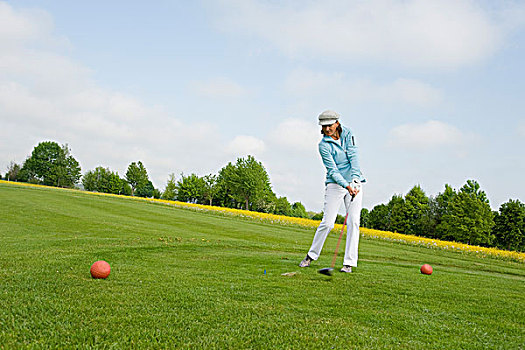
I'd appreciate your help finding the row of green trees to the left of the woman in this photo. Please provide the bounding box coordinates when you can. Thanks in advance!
[5,141,308,218]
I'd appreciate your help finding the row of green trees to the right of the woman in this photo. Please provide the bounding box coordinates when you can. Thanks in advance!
[361,180,525,251]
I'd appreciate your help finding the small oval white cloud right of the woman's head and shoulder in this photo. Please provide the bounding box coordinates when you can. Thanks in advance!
[388,120,466,150]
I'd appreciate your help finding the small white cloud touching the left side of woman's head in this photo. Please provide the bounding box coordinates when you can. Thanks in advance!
[270,118,321,153]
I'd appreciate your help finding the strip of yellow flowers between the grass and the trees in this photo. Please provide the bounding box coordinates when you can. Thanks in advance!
[0,180,525,262]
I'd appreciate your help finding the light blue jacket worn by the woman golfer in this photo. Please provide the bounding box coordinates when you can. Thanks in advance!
[319,126,366,187]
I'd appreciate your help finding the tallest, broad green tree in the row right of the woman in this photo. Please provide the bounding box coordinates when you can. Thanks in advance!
[440,185,494,246]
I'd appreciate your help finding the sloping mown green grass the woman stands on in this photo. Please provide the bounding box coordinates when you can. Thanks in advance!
[0,183,525,349]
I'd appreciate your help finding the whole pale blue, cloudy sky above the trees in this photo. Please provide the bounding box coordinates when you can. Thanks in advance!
[0,0,525,211]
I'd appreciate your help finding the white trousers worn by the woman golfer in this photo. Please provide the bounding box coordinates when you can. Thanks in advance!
[308,183,363,266]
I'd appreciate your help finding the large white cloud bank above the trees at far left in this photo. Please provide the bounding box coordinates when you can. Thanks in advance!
[0,2,227,188]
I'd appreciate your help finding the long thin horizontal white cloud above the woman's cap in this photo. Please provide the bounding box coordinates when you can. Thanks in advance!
[284,68,442,107]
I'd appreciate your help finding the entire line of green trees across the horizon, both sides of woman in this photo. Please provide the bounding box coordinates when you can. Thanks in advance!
[4,141,525,251]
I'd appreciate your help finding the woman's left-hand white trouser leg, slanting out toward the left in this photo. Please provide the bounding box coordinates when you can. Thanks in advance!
[308,184,348,260]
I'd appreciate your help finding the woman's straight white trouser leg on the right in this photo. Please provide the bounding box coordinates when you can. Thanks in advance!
[343,186,363,266]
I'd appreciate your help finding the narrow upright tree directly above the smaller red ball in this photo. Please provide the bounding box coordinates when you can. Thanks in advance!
[404,185,429,236]
